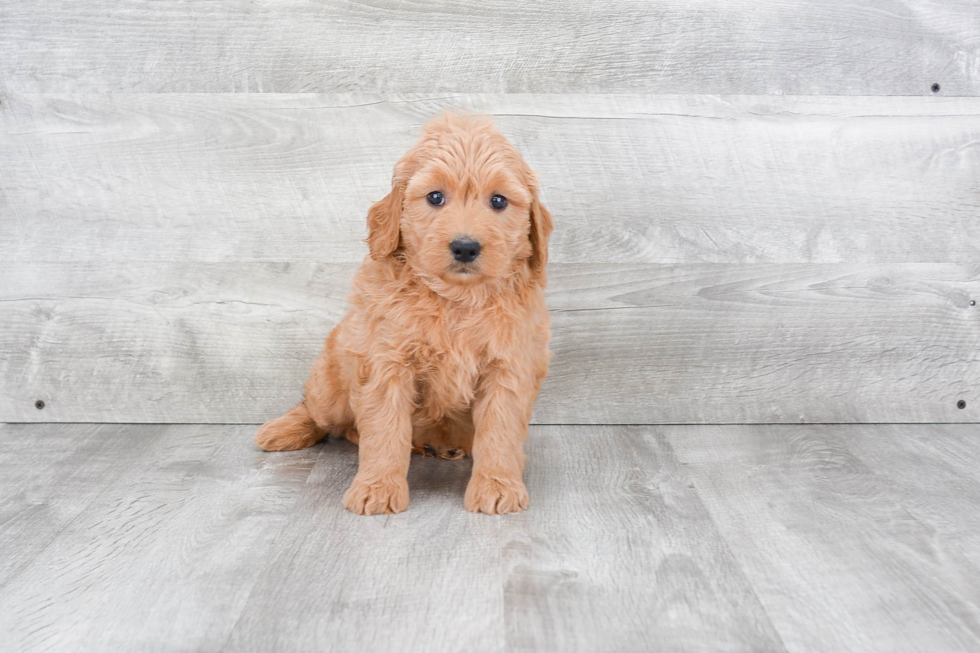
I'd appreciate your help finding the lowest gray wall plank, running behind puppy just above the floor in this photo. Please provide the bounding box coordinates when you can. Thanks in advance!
[0,263,980,424]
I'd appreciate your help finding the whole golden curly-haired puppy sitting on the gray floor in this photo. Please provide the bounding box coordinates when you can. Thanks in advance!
[255,115,552,515]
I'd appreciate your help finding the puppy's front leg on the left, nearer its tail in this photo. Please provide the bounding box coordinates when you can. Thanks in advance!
[344,363,415,515]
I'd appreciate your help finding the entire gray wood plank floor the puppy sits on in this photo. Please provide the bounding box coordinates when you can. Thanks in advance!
[0,424,980,652]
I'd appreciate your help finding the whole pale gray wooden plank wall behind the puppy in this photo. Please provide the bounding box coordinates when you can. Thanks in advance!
[0,0,980,423]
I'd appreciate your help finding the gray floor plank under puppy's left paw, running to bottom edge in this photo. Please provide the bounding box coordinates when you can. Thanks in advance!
[225,440,505,652]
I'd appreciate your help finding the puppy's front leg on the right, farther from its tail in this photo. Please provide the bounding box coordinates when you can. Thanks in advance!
[463,366,536,515]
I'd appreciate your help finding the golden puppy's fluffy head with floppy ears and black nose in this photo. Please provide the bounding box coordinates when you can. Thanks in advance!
[368,114,552,286]
